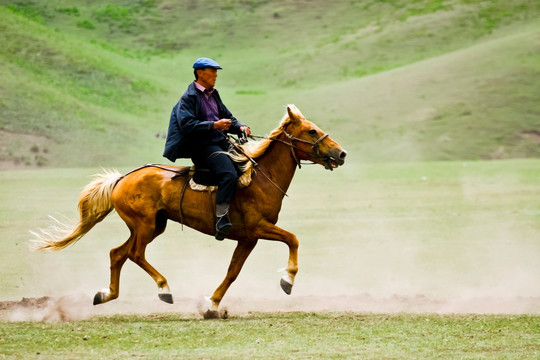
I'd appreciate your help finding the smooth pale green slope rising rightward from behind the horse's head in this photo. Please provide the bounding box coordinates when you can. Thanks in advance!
[297,24,540,161]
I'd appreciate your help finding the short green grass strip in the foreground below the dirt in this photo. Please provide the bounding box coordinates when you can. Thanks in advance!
[0,313,540,359]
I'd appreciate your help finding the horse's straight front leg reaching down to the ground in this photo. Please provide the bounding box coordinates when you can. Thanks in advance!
[203,240,257,319]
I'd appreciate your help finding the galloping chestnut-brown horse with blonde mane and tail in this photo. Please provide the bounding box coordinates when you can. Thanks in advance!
[34,105,346,317]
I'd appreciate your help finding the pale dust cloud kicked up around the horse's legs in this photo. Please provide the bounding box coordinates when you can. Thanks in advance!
[0,235,540,322]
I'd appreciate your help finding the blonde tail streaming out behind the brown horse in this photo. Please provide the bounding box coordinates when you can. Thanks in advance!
[30,170,122,251]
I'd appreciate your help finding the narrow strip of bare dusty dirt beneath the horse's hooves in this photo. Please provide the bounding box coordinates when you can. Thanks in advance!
[0,294,540,322]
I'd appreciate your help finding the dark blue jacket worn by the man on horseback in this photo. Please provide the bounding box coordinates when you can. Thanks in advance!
[163,83,244,162]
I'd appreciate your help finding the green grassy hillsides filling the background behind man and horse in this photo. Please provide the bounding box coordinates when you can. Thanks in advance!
[0,0,540,168]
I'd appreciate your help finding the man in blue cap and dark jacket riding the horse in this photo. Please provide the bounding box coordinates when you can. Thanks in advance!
[163,58,251,240]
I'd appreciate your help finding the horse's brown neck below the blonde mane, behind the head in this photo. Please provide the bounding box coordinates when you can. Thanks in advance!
[258,135,297,198]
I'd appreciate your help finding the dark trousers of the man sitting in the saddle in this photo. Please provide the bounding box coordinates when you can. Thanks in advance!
[191,142,238,204]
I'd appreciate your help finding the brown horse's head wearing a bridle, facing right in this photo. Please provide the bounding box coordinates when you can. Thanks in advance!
[282,105,347,170]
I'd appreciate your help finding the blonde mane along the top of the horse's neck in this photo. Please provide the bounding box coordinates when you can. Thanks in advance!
[223,104,304,187]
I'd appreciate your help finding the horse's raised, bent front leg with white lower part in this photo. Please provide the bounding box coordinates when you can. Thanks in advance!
[255,221,298,295]
